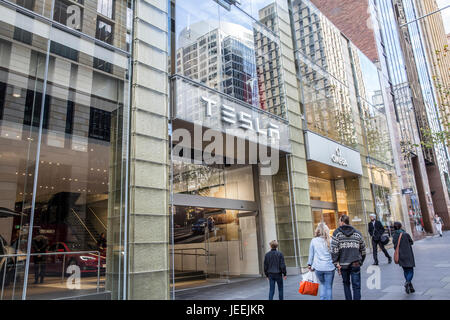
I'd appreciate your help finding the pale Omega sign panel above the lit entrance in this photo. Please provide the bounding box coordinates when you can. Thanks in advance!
[305,131,362,175]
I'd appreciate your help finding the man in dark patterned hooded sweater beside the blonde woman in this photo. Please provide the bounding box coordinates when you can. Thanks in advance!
[331,215,366,300]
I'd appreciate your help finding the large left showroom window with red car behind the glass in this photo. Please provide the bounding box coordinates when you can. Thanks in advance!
[0,0,129,299]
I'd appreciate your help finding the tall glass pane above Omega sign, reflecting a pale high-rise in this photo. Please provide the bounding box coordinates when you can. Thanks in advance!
[292,0,357,146]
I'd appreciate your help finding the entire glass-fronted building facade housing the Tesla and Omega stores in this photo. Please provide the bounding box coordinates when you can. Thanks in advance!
[0,0,442,299]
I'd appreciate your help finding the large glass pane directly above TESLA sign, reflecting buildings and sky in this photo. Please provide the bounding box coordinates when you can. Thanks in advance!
[172,0,286,117]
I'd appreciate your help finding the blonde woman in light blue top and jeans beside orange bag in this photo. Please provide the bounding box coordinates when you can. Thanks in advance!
[308,222,336,300]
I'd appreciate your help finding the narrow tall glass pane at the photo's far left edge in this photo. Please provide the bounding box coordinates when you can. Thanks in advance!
[0,31,48,300]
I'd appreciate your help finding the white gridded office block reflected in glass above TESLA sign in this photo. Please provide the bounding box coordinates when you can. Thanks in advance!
[176,22,258,106]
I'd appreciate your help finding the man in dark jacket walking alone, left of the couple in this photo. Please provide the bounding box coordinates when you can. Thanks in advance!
[264,240,286,300]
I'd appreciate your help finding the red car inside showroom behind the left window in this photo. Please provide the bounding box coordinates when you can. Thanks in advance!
[46,242,106,275]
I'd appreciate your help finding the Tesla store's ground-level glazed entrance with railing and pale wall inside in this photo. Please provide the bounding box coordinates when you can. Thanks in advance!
[171,206,260,289]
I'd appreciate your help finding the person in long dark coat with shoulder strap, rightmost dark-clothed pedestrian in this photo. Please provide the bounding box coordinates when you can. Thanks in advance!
[392,222,416,294]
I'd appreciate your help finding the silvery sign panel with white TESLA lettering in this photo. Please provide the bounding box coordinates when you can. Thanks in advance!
[172,75,290,153]
